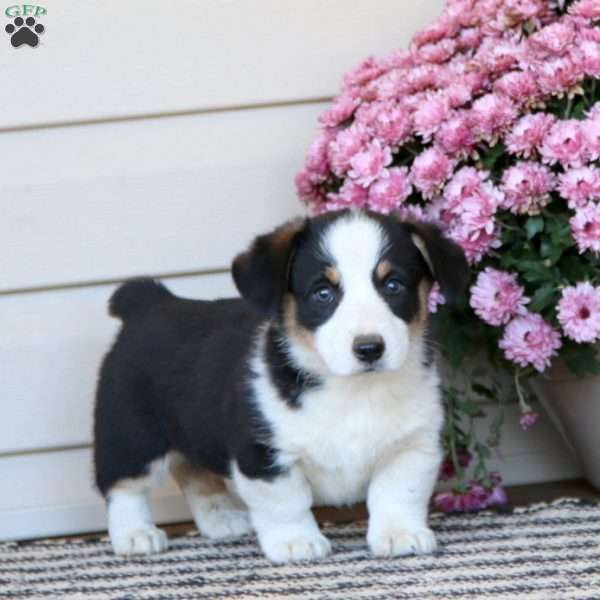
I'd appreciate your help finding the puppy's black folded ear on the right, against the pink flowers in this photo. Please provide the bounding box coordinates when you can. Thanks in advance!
[407,222,469,304]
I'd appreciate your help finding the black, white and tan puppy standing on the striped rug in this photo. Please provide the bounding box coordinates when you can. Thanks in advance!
[94,210,468,562]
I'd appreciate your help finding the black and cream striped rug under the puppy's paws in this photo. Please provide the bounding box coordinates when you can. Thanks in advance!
[0,500,600,600]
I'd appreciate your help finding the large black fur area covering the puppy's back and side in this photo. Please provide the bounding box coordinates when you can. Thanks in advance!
[94,280,282,494]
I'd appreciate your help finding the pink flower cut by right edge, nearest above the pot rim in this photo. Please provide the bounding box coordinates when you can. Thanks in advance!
[557,281,600,344]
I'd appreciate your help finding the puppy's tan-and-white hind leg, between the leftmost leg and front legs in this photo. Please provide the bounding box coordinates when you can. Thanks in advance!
[170,454,252,539]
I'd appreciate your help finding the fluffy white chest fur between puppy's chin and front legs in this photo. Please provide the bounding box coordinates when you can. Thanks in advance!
[255,350,442,505]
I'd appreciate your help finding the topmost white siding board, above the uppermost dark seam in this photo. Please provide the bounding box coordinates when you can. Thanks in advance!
[0,0,443,130]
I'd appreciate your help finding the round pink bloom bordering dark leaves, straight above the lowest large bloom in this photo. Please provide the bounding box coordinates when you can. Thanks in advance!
[501,161,555,215]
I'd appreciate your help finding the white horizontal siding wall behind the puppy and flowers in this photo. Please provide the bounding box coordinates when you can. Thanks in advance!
[0,0,578,539]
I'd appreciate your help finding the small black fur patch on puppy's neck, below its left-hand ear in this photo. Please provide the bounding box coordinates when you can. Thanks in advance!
[265,326,321,408]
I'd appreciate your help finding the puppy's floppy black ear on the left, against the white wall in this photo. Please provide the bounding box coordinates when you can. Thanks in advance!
[232,218,306,316]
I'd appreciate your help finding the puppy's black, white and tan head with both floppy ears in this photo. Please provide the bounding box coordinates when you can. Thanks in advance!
[233,211,468,376]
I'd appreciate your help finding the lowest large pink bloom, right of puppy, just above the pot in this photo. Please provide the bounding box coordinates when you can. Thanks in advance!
[498,313,562,373]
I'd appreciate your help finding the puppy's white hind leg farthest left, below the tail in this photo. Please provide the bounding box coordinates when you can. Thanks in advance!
[106,458,167,554]
